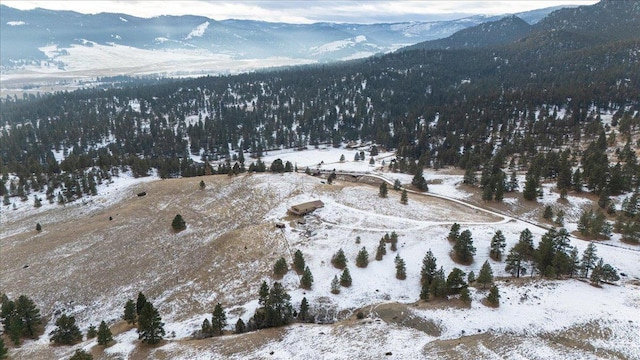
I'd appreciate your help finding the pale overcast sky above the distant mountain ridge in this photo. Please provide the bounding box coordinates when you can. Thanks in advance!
[2,0,597,24]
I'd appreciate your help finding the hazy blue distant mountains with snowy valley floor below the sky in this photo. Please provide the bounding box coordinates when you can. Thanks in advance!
[0,5,555,75]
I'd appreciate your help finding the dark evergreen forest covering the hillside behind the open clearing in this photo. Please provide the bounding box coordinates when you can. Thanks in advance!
[0,1,640,212]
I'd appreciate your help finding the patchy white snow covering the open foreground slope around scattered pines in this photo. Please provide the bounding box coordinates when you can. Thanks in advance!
[0,148,640,359]
